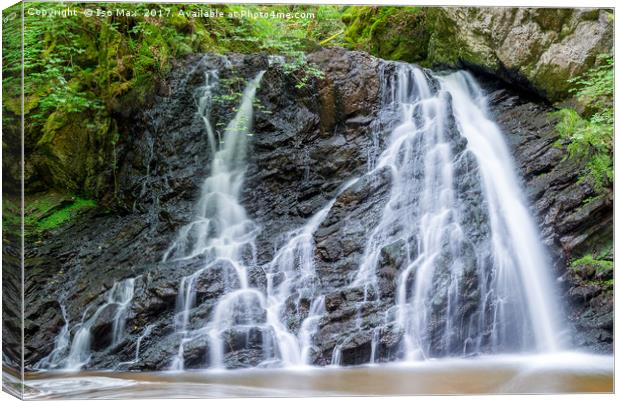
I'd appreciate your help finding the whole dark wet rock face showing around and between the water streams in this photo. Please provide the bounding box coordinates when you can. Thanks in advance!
[25,49,612,370]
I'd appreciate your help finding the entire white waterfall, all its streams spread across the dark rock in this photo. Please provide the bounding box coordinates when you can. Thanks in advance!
[36,59,559,370]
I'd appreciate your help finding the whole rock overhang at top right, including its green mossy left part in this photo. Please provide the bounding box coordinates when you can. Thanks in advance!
[343,7,613,102]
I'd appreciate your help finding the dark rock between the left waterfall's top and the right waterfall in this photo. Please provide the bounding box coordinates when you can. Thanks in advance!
[242,49,380,263]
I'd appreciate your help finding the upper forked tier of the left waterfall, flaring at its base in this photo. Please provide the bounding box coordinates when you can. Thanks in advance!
[163,72,263,262]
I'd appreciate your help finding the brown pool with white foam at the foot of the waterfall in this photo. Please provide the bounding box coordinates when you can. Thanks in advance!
[19,353,613,399]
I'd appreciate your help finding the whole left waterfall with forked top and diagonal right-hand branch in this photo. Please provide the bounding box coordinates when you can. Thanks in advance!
[163,63,364,370]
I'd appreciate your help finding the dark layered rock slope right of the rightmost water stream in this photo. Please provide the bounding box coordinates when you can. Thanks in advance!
[486,75,613,352]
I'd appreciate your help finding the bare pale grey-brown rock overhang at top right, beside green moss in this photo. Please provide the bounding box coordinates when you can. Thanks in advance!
[429,7,613,101]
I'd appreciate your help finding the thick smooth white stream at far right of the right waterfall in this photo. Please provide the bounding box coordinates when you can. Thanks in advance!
[444,72,559,351]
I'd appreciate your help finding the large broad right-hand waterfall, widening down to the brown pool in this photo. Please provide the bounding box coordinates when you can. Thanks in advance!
[354,63,558,362]
